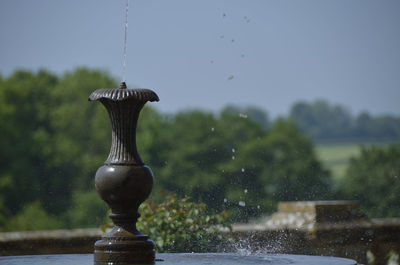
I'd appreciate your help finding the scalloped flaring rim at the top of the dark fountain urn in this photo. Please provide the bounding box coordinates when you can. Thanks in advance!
[89,88,159,102]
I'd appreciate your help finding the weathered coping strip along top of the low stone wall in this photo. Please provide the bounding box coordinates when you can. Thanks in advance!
[0,218,400,248]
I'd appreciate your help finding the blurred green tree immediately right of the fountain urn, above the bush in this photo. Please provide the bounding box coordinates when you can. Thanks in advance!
[151,108,261,212]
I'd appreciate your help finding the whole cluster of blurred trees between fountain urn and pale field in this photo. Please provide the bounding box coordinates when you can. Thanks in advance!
[144,110,330,221]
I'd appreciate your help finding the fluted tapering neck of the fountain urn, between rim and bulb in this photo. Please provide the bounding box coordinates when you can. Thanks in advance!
[100,98,145,165]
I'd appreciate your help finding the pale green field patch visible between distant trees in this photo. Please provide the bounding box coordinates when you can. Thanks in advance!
[315,142,396,179]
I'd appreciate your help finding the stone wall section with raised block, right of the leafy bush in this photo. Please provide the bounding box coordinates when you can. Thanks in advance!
[233,201,400,265]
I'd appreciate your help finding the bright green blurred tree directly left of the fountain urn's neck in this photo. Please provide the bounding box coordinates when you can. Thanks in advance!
[51,68,117,191]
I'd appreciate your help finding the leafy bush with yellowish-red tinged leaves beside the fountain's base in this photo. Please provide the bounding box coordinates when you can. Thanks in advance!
[103,194,230,253]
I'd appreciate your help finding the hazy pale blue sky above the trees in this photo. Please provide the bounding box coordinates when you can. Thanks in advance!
[0,0,400,116]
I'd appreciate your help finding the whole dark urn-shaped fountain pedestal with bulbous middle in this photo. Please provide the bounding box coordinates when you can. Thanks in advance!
[89,83,159,265]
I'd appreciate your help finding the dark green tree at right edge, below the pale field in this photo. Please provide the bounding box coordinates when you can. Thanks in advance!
[341,144,400,217]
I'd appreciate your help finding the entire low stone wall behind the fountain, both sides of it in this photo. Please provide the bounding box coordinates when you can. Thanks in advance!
[0,201,400,265]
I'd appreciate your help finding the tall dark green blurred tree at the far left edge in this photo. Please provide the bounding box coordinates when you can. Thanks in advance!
[0,70,59,215]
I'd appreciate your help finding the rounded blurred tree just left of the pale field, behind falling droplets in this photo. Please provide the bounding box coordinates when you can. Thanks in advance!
[222,119,331,221]
